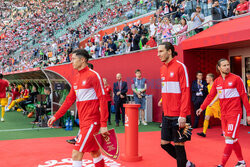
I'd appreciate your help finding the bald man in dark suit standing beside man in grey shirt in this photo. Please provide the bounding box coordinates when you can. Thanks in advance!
[113,73,128,126]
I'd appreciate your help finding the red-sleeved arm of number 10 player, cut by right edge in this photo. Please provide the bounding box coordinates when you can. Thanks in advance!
[237,79,250,124]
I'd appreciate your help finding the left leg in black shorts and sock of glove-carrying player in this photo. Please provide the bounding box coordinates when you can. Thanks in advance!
[161,116,176,159]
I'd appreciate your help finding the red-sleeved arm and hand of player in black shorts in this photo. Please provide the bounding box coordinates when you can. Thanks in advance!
[178,65,191,128]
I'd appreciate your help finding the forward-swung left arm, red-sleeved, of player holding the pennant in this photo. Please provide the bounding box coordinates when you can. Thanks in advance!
[48,87,76,126]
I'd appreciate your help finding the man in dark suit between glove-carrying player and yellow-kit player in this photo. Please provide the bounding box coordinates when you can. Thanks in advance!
[192,71,208,128]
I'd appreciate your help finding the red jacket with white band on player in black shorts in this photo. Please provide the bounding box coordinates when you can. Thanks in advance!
[161,58,191,117]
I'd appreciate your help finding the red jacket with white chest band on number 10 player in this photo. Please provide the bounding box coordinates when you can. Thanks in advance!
[201,73,250,116]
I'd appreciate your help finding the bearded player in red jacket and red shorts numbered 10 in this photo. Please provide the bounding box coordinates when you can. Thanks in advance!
[197,59,250,167]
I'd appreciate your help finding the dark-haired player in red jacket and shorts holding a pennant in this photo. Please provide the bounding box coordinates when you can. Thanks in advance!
[48,49,108,167]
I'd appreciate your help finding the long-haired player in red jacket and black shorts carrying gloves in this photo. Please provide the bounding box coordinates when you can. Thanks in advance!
[158,42,195,167]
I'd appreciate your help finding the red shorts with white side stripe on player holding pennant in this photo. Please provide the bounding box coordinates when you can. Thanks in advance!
[74,122,100,152]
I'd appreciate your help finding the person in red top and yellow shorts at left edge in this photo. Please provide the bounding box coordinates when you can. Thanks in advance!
[0,74,9,122]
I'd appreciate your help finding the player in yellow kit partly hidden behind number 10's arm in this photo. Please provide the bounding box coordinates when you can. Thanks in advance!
[197,73,221,137]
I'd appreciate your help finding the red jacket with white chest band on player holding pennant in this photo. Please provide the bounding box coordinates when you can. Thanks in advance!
[54,67,109,128]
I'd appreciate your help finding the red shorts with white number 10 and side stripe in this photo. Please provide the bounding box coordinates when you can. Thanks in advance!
[221,114,242,139]
